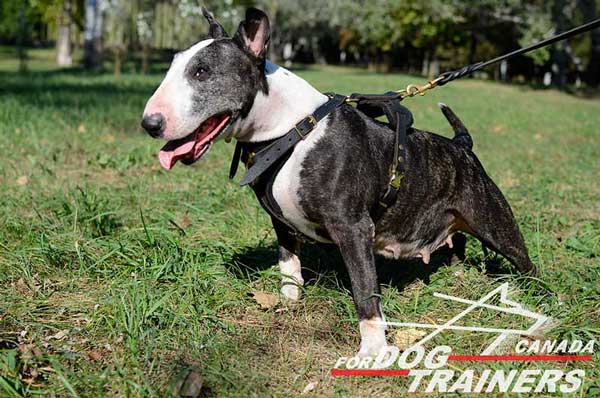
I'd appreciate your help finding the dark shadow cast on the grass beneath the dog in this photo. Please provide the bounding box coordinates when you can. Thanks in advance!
[225,234,486,290]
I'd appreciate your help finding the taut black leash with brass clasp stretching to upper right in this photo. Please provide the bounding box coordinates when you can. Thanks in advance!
[396,18,600,100]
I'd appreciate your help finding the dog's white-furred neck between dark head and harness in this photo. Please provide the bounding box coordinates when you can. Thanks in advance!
[233,61,327,142]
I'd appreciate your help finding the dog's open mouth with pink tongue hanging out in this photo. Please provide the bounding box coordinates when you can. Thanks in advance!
[158,113,231,170]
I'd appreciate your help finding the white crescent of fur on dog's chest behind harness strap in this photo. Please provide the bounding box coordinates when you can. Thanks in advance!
[273,117,331,243]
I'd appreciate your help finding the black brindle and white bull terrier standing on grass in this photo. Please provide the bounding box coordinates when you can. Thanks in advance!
[142,9,535,356]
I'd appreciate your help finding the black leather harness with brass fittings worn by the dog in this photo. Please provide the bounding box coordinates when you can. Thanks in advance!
[229,92,413,240]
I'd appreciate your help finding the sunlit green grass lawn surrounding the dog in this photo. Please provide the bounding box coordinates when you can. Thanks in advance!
[0,48,600,397]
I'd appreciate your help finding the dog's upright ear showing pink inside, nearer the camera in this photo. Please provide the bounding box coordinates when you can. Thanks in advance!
[233,8,271,62]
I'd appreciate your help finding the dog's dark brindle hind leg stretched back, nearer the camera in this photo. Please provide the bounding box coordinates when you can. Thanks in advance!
[460,183,537,275]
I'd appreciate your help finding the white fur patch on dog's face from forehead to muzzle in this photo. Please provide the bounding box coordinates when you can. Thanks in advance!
[144,39,214,140]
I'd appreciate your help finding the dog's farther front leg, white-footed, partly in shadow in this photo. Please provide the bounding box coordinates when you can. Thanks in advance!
[271,218,304,300]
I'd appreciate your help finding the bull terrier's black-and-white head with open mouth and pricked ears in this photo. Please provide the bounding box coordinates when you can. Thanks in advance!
[142,8,269,169]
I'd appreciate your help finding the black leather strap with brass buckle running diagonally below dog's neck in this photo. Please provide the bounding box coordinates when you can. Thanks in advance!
[237,94,347,186]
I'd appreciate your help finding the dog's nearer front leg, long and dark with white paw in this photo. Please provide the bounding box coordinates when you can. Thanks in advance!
[327,217,386,357]
